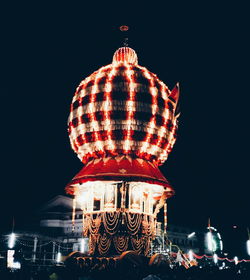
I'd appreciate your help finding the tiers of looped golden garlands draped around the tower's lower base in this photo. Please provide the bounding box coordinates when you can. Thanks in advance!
[79,211,155,256]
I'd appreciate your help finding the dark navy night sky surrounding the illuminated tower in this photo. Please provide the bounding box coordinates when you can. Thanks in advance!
[0,1,250,247]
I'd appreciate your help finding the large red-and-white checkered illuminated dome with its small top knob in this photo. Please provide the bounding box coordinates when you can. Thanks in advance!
[68,47,179,164]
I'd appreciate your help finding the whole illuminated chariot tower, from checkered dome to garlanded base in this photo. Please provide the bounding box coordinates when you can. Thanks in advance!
[66,47,179,255]
